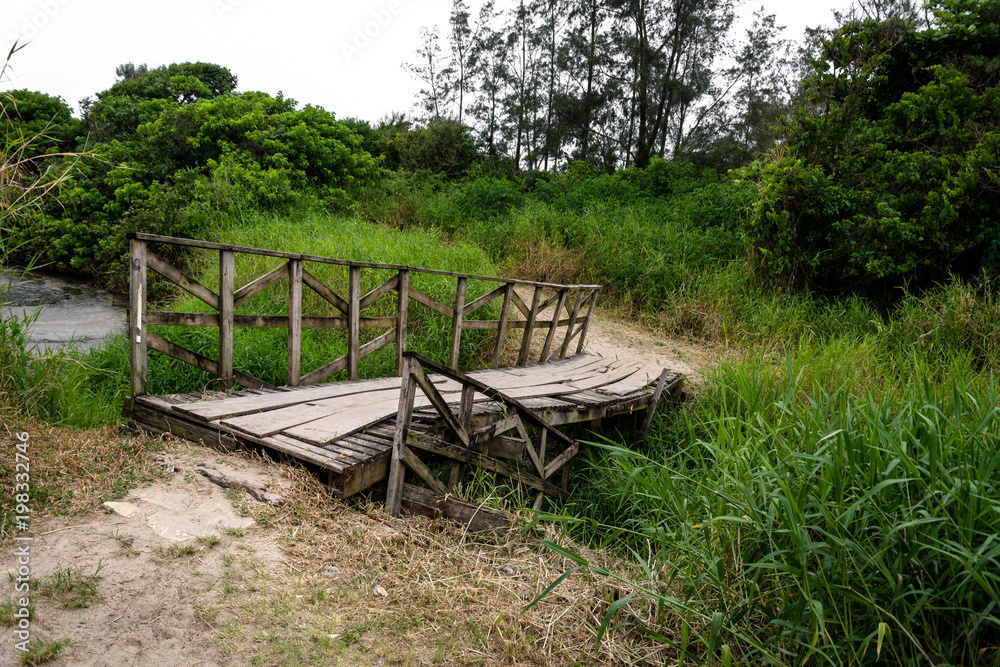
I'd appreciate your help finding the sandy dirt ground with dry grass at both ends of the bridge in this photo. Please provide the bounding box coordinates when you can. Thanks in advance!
[0,317,713,667]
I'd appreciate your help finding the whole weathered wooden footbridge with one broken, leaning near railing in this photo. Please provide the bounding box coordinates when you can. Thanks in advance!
[124,233,682,527]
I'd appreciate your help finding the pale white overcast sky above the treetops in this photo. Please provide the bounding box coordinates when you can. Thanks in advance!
[0,0,850,121]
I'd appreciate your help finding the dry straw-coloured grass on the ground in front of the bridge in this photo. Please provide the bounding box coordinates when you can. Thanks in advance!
[0,419,676,665]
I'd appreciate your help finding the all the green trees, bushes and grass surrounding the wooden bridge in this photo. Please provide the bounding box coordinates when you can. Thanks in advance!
[0,0,1000,665]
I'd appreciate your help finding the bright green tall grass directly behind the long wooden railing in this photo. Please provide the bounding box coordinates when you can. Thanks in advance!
[81,211,498,402]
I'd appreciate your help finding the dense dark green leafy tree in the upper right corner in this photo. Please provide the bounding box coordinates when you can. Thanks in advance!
[744,0,1000,292]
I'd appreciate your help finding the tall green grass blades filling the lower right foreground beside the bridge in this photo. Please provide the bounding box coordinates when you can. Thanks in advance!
[548,344,1000,665]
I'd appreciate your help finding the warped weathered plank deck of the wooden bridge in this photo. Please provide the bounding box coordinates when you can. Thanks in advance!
[125,354,681,497]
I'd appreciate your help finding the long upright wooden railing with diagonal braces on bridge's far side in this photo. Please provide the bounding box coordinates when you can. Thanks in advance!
[128,232,601,396]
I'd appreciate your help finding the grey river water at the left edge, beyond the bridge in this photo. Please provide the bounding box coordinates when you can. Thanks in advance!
[0,272,127,350]
